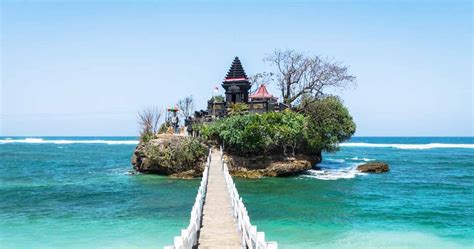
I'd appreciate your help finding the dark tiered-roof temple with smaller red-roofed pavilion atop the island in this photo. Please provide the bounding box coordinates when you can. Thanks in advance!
[205,57,287,117]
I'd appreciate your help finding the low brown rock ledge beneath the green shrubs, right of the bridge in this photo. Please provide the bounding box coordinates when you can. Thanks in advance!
[224,154,321,178]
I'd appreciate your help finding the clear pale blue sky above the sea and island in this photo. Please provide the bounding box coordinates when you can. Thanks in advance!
[0,0,474,136]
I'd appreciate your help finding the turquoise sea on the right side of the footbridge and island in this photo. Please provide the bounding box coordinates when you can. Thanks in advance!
[237,138,474,248]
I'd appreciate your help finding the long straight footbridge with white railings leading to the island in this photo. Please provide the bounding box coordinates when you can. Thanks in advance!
[165,148,278,249]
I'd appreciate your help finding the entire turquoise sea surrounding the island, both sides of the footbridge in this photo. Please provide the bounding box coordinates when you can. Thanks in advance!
[0,137,474,248]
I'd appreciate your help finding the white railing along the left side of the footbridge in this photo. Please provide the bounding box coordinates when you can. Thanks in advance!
[164,150,211,249]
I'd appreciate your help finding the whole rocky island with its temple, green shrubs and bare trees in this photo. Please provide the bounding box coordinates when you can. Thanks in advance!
[132,50,362,178]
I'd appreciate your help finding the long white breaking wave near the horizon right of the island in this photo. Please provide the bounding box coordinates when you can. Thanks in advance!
[340,143,474,150]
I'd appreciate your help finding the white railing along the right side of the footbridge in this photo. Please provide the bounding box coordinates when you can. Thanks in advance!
[221,147,278,249]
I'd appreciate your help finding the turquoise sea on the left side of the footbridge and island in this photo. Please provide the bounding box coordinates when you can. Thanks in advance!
[0,138,199,248]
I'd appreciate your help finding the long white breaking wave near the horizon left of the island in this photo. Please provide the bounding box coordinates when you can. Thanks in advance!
[0,138,138,145]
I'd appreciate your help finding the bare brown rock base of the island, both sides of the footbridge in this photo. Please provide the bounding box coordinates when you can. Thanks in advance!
[132,134,321,178]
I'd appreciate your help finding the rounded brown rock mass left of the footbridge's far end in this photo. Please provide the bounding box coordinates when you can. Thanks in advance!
[131,134,207,178]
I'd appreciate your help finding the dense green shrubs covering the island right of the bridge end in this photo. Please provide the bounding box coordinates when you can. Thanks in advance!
[195,96,356,156]
